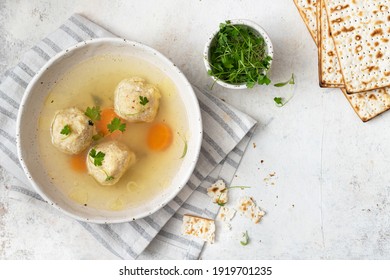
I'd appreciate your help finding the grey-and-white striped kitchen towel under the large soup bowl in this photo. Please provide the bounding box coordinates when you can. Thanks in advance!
[0,15,256,259]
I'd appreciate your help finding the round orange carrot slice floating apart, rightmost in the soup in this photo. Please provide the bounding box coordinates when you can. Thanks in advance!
[147,123,173,151]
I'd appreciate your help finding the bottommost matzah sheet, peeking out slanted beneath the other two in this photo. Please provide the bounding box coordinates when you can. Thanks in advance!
[294,0,390,122]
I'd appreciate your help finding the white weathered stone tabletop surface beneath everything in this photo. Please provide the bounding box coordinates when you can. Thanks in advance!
[0,0,390,259]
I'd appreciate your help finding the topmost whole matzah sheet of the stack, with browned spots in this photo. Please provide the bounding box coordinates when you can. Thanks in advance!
[324,0,390,93]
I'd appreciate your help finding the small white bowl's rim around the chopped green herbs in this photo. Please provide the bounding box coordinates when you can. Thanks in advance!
[203,19,274,89]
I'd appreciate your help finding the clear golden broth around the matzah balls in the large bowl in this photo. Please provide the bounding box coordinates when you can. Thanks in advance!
[39,56,188,210]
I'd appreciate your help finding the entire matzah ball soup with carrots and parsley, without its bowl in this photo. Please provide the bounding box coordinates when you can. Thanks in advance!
[39,55,188,210]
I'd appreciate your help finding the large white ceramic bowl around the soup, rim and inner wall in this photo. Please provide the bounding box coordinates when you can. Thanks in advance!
[17,38,202,223]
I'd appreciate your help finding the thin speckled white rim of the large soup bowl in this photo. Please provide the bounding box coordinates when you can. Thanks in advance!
[16,37,203,224]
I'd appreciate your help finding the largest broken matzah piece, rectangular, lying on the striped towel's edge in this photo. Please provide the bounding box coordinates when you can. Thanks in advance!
[182,214,215,244]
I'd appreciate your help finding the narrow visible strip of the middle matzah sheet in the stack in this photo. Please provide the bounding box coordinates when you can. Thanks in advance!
[316,0,344,88]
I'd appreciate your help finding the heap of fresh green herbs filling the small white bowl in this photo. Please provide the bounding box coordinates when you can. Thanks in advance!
[208,21,272,88]
